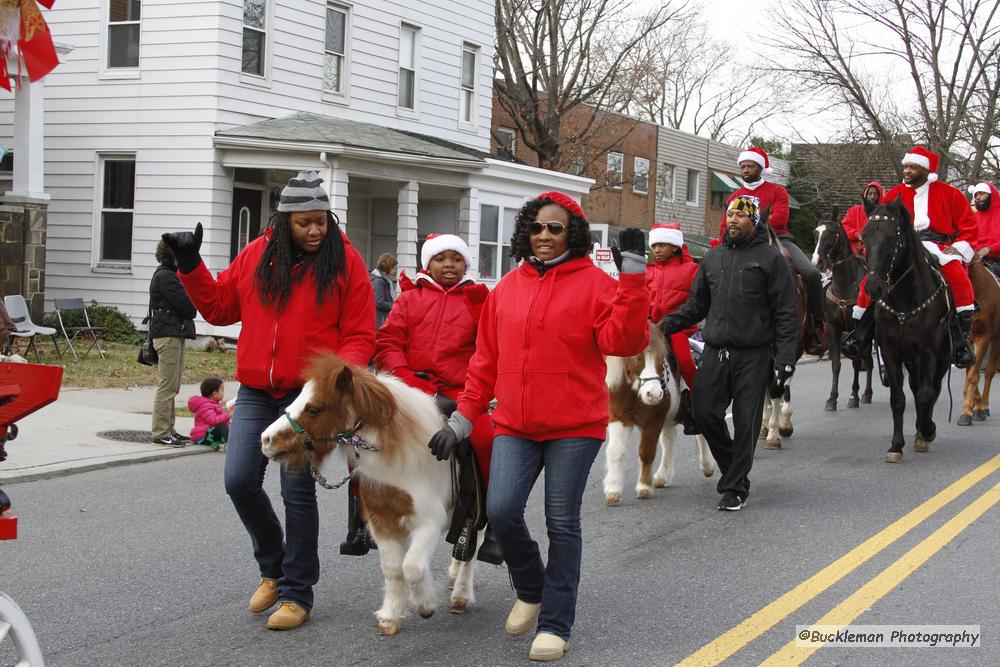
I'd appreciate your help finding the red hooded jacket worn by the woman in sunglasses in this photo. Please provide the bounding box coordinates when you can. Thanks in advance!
[458,257,649,441]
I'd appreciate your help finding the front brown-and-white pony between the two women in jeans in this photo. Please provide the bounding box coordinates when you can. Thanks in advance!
[261,354,475,635]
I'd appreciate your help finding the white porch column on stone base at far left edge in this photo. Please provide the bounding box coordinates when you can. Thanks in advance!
[7,74,49,200]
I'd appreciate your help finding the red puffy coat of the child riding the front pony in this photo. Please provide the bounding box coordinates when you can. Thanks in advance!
[375,273,487,399]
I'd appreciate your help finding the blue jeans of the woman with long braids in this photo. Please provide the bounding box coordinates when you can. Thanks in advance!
[224,387,319,609]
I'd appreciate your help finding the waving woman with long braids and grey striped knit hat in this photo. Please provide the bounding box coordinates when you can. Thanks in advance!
[163,172,375,630]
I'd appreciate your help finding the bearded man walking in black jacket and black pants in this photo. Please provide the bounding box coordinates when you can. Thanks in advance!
[660,195,798,511]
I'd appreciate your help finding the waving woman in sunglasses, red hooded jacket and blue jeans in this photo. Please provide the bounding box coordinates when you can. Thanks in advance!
[429,192,649,660]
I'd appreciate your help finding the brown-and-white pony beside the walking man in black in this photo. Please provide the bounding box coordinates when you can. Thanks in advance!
[604,324,715,505]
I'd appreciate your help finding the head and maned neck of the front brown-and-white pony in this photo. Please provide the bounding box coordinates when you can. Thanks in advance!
[260,353,441,468]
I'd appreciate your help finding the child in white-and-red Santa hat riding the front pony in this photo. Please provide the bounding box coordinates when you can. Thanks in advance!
[375,234,501,563]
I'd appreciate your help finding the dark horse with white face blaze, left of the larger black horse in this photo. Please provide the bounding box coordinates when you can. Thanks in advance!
[812,217,874,412]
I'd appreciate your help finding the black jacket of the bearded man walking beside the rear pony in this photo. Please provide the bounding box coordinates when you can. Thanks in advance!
[660,225,799,365]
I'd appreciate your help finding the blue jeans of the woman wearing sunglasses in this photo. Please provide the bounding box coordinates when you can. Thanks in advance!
[486,435,601,640]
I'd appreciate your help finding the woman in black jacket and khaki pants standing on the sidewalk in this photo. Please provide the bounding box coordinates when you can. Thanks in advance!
[149,240,198,447]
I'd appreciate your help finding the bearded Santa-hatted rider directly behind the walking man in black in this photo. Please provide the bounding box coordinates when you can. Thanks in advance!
[719,147,826,354]
